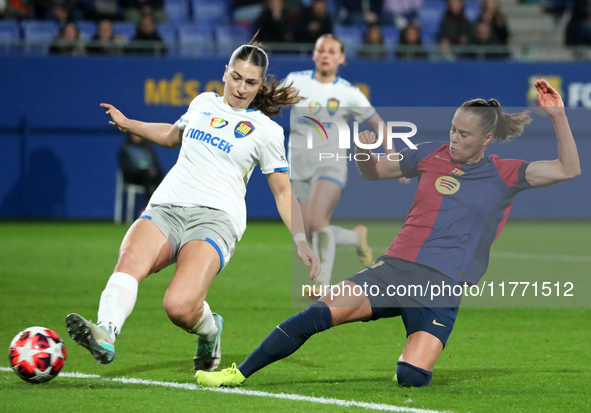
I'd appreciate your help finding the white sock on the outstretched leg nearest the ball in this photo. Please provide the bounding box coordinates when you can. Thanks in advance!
[97,272,138,342]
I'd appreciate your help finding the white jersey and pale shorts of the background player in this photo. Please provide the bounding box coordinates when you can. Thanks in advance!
[284,70,376,180]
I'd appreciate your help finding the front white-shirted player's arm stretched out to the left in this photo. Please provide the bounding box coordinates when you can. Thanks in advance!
[101,103,183,148]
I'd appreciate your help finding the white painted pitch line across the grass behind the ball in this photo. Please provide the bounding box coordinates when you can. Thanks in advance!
[0,367,448,413]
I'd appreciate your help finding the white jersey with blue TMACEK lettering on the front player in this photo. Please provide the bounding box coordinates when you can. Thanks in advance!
[150,93,288,239]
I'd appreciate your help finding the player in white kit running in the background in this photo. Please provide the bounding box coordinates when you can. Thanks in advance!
[284,34,404,285]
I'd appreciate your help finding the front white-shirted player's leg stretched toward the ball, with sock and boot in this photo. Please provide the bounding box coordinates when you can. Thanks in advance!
[66,219,170,364]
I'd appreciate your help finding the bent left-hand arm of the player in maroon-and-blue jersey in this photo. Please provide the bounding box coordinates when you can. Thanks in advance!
[355,131,403,181]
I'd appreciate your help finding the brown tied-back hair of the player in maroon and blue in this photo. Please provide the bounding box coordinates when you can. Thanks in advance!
[460,99,532,142]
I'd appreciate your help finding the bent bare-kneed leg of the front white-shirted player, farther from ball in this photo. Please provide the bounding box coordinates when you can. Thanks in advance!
[164,240,224,370]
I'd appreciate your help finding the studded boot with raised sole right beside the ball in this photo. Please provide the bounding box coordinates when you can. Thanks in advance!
[66,313,115,364]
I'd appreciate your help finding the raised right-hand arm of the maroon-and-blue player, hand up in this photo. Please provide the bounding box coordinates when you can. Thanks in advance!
[525,79,581,187]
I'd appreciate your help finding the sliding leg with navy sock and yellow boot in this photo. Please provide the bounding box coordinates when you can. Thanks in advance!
[195,281,372,387]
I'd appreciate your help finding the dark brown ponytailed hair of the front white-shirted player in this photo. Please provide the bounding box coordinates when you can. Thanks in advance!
[228,43,305,117]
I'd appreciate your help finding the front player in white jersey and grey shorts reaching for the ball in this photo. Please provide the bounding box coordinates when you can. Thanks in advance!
[66,45,320,370]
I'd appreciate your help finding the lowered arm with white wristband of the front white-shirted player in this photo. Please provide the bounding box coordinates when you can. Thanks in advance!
[267,172,320,279]
